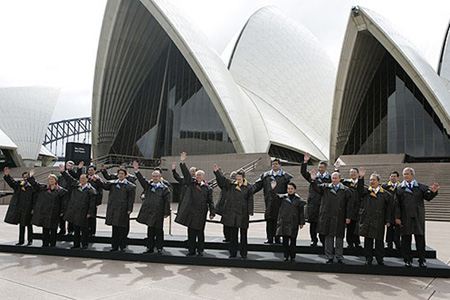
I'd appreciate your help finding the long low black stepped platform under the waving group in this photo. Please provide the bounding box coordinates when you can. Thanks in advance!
[0,232,450,278]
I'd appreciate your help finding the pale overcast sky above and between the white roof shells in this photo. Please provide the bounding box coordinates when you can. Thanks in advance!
[0,0,450,121]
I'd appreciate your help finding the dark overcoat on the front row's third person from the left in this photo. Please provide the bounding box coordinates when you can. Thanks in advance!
[61,171,97,227]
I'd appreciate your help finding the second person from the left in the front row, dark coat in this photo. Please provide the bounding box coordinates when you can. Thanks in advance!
[30,174,67,247]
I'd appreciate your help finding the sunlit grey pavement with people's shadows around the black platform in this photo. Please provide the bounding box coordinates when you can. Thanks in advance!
[0,205,450,300]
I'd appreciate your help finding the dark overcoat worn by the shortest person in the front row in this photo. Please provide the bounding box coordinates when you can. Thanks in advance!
[276,194,306,239]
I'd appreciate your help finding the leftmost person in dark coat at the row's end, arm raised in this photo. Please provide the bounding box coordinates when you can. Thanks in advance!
[3,167,34,245]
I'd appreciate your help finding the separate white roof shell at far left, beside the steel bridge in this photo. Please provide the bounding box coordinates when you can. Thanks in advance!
[0,86,59,161]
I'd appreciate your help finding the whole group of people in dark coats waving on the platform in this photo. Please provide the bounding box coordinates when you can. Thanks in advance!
[4,152,439,267]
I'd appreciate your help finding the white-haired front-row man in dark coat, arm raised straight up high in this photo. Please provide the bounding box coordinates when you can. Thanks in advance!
[175,152,215,256]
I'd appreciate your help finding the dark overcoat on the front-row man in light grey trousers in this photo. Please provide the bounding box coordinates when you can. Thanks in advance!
[313,181,352,238]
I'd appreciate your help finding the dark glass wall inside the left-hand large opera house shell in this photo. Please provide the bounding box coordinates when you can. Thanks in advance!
[110,42,236,158]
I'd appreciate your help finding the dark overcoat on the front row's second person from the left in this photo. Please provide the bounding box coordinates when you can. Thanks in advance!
[31,180,67,229]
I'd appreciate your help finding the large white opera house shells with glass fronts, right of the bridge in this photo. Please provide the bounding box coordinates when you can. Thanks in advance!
[92,0,450,161]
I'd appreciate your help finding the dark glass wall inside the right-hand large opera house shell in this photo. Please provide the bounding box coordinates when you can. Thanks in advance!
[343,52,450,157]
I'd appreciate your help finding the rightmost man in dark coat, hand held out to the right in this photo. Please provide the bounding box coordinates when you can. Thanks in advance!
[394,167,440,268]
